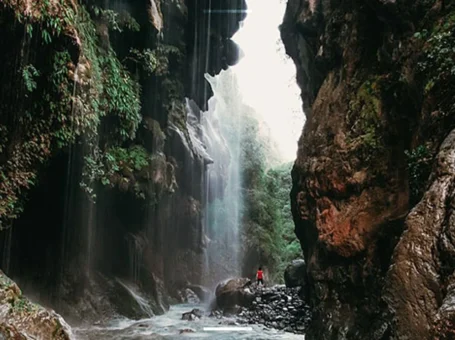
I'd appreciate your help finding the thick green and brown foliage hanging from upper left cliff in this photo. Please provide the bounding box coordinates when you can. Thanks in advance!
[0,0,146,226]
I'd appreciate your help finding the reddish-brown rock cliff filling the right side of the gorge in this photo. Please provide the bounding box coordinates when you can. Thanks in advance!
[281,0,455,339]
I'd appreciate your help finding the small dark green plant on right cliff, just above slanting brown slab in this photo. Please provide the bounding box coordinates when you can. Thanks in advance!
[405,145,433,205]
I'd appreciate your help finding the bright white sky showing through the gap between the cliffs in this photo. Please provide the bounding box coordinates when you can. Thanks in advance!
[232,0,305,161]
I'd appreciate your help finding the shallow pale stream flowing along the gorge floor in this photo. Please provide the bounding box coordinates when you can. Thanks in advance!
[74,304,305,340]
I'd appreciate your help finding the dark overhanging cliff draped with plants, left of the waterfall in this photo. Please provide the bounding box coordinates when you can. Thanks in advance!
[0,0,245,321]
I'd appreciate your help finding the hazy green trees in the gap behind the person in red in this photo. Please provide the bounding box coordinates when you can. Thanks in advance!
[215,108,302,283]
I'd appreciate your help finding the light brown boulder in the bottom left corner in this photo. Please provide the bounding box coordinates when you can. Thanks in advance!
[0,271,71,340]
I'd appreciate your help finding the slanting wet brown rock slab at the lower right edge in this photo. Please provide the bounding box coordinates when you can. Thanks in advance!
[384,130,455,339]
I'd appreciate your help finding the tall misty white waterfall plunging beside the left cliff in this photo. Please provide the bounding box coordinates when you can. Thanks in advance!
[201,70,245,286]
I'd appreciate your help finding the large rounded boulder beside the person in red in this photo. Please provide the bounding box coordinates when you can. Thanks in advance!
[215,278,254,309]
